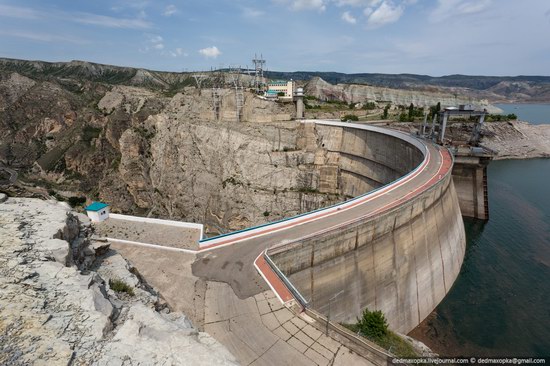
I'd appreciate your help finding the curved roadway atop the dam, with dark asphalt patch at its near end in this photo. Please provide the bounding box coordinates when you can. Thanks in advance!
[192,120,453,302]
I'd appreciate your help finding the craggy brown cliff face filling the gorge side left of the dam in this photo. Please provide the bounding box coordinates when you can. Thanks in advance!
[0,68,350,233]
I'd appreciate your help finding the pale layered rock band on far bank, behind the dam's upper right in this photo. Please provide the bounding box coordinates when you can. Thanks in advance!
[305,77,500,113]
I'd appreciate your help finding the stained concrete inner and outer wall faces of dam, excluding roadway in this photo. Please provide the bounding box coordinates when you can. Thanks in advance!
[268,121,466,333]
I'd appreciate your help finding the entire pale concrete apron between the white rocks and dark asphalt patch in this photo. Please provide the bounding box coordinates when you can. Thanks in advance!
[111,243,372,366]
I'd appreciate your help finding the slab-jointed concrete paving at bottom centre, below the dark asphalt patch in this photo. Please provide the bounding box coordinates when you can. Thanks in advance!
[204,282,369,366]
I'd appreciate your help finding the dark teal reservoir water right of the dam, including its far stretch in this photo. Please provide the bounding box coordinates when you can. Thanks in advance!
[411,105,550,357]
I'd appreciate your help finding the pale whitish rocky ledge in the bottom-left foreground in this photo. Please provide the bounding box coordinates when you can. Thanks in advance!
[0,194,236,365]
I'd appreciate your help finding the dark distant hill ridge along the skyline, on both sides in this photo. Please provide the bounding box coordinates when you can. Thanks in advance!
[0,58,550,103]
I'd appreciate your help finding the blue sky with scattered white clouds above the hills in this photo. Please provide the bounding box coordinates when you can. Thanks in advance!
[0,0,550,76]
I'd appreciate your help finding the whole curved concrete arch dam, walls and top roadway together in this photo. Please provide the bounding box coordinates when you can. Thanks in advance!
[193,121,466,333]
